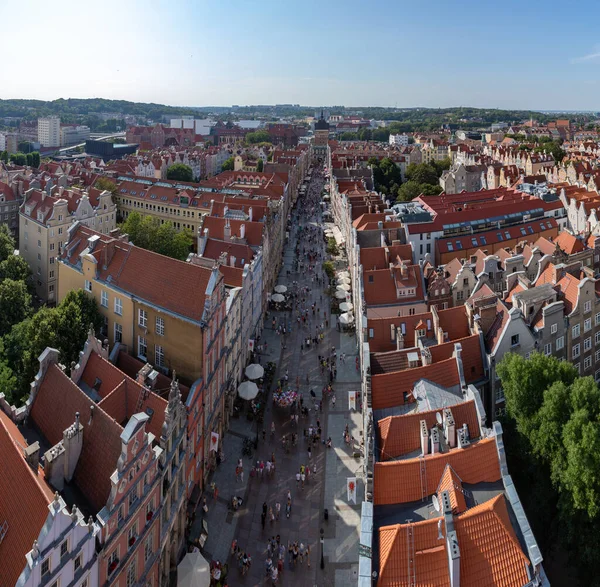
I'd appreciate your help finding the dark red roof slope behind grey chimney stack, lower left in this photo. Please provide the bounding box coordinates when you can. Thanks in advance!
[31,364,123,511]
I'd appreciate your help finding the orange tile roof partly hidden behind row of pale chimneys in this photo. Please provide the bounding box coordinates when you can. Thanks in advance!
[377,400,481,461]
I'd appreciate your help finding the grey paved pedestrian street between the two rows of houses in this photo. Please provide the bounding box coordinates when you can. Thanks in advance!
[195,167,363,587]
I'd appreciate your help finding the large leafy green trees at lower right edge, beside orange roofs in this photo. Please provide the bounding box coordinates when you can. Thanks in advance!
[497,353,600,585]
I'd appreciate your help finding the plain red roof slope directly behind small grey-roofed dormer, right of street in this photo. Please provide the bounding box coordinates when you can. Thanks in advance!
[371,358,460,410]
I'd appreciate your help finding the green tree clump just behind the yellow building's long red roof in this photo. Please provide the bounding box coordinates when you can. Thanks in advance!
[121,212,193,261]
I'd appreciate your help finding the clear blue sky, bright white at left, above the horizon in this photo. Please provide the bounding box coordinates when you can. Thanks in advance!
[0,0,600,110]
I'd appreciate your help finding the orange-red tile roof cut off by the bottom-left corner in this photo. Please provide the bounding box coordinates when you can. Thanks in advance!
[0,411,53,585]
